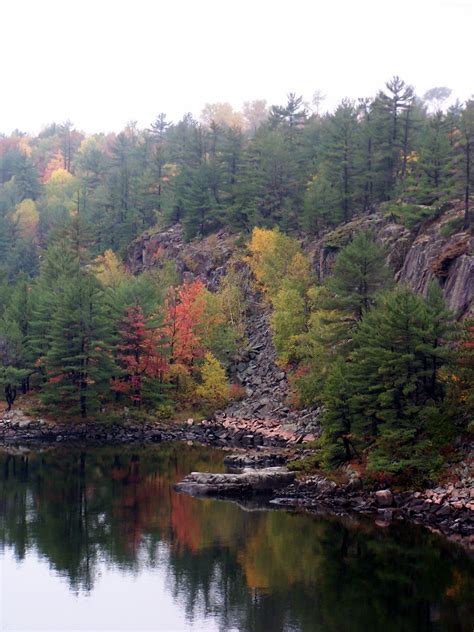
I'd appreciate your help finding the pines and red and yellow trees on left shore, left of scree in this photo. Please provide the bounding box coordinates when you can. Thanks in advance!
[0,215,241,418]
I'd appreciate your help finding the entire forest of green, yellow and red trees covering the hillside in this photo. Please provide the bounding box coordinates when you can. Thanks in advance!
[0,77,474,475]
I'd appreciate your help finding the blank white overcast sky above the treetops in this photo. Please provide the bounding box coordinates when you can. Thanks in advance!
[0,0,474,133]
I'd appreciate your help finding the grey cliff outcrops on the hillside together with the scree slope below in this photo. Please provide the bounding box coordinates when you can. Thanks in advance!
[127,204,474,437]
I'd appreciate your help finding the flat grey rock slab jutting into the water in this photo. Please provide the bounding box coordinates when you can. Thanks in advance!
[175,467,295,496]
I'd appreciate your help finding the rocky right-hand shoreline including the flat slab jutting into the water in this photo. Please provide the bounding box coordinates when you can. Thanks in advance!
[169,451,474,551]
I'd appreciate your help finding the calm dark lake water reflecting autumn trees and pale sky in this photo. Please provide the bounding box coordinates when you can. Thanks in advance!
[0,445,474,632]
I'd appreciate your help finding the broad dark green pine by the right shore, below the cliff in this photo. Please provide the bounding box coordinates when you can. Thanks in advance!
[348,286,451,473]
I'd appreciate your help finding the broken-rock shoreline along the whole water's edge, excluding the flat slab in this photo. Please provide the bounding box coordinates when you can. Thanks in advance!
[0,409,474,549]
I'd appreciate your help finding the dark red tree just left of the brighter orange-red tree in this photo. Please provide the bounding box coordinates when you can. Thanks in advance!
[112,306,168,406]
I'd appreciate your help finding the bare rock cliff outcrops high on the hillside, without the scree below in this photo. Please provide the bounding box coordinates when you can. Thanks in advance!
[127,203,474,318]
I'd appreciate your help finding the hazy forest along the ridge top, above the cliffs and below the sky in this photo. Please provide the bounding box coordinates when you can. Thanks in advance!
[0,77,474,286]
